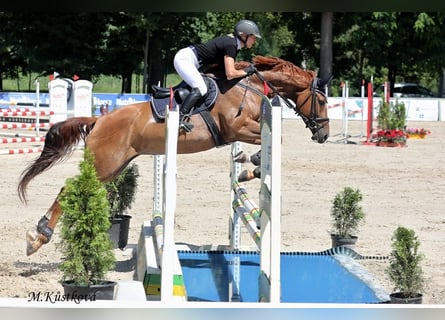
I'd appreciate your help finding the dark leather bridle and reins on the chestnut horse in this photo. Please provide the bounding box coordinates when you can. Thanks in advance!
[251,70,329,134]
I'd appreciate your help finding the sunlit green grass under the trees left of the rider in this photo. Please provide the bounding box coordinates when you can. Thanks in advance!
[3,73,181,93]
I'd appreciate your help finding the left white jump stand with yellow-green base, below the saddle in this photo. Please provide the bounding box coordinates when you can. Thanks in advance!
[136,105,187,302]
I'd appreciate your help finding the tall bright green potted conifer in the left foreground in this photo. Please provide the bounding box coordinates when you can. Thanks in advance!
[59,149,116,300]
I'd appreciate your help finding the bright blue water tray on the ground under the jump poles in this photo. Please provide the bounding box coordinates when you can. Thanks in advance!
[178,250,384,303]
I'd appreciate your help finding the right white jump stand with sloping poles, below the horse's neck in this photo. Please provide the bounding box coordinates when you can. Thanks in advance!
[229,97,282,303]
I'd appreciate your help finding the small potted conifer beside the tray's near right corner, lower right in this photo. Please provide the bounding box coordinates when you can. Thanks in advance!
[386,227,425,304]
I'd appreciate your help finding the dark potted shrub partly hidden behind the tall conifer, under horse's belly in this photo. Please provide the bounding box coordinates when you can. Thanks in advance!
[105,163,139,249]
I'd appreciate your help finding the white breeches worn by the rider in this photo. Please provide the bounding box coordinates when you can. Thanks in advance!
[173,47,207,96]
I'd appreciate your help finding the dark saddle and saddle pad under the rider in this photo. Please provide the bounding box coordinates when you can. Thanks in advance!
[151,75,218,122]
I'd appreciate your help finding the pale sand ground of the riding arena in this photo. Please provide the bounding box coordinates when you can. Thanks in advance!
[0,120,445,304]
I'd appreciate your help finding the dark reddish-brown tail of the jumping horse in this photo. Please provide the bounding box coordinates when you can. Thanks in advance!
[17,117,97,203]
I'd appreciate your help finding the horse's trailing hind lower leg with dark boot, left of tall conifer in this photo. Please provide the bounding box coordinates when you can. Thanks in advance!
[26,189,63,256]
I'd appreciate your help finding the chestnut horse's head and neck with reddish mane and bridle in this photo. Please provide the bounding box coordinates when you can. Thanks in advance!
[253,56,330,143]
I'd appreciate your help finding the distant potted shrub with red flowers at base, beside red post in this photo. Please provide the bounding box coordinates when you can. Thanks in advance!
[374,100,407,147]
